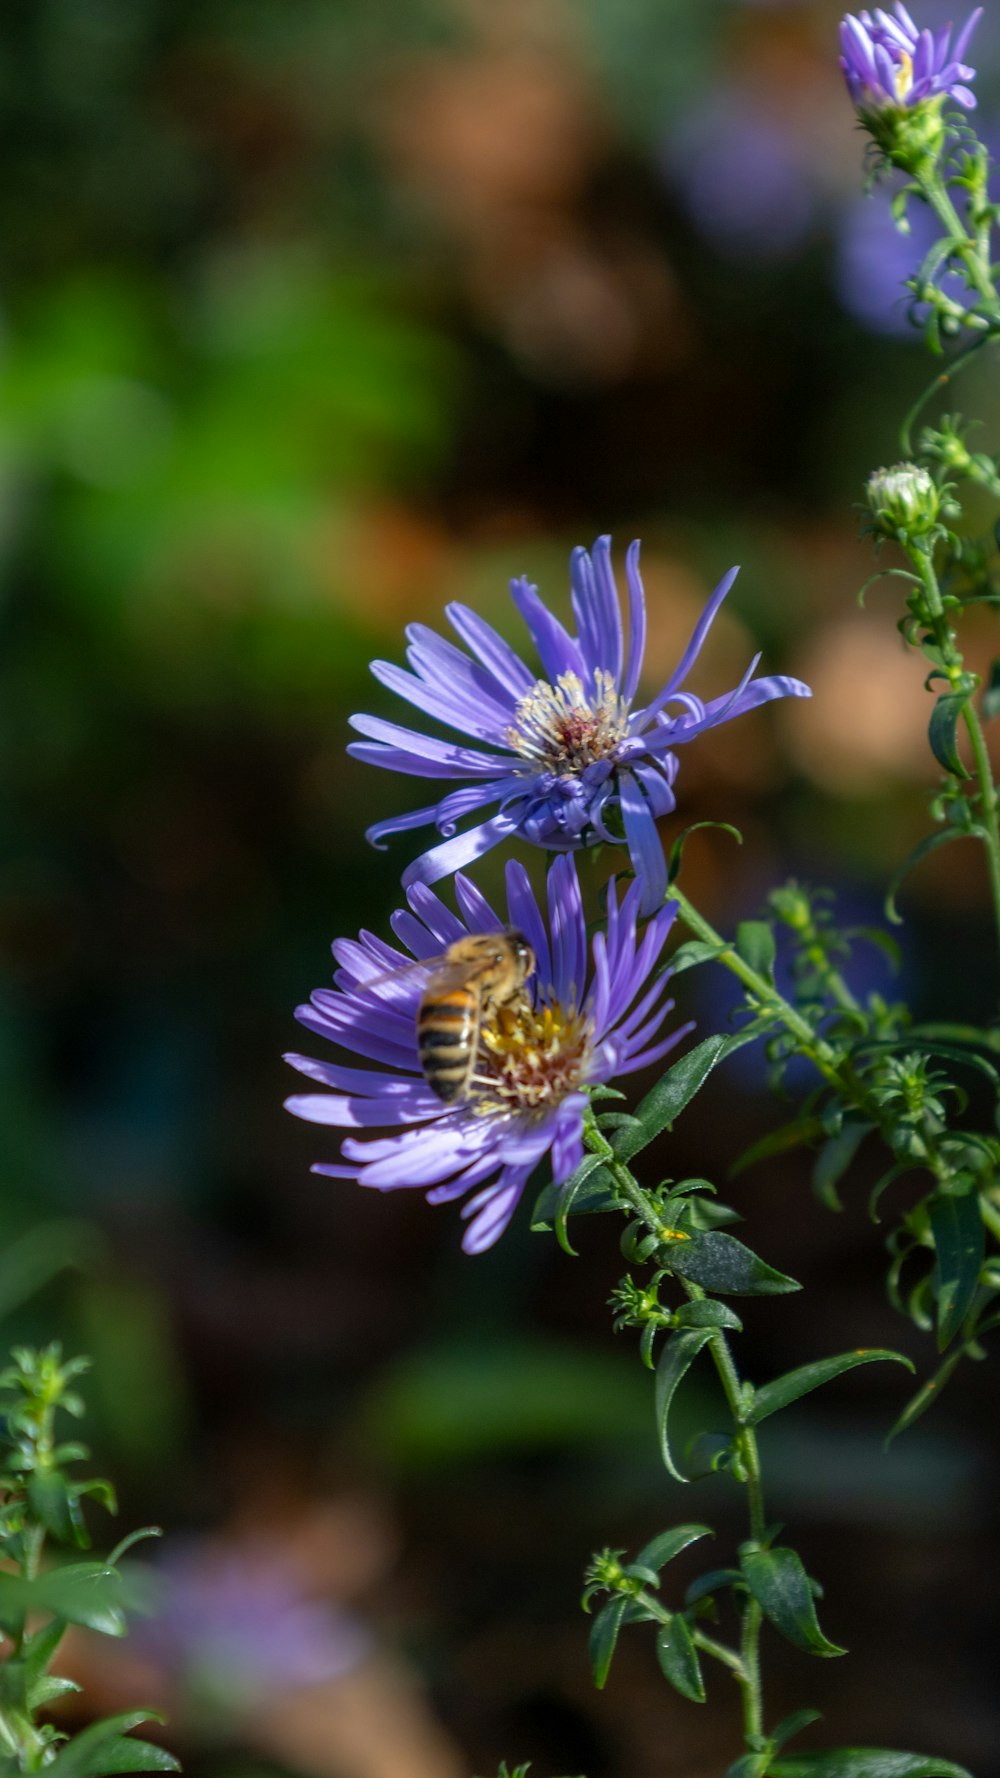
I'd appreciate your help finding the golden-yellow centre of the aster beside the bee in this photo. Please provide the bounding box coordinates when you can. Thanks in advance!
[473,994,593,1113]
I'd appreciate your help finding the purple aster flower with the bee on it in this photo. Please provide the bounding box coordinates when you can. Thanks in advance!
[286,857,690,1253]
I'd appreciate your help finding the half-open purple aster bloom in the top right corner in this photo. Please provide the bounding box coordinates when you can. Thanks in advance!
[840,0,982,116]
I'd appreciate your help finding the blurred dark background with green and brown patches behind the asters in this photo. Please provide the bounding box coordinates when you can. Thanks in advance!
[0,0,1000,1778]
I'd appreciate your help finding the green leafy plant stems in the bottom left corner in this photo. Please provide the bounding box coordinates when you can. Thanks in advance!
[0,1344,178,1778]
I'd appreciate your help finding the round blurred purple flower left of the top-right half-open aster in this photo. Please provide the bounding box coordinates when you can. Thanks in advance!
[665,89,819,260]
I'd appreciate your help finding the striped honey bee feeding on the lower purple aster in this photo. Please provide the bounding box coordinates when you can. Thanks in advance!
[416,932,537,1104]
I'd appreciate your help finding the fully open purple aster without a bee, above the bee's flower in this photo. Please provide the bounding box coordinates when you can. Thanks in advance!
[349,537,810,914]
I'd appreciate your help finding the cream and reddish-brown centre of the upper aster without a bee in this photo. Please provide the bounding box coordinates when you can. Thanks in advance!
[507,667,628,777]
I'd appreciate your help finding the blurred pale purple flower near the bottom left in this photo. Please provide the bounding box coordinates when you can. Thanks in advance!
[133,1543,370,1707]
